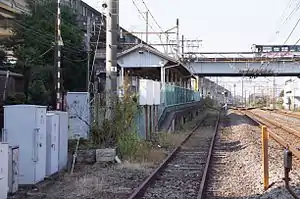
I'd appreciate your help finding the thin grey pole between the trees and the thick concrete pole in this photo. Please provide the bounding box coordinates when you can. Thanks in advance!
[85,16,91,93]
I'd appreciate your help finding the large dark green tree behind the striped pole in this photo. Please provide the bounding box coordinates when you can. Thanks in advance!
[5,0,86,105]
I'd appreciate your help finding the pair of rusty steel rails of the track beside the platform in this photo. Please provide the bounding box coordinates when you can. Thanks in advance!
[128,112,220,199]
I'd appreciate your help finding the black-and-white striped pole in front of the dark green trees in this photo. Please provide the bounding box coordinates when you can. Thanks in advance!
[54,0,63,110]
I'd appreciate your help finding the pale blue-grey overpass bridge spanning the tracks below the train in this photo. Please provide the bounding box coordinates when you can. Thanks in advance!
[185,52,300,77]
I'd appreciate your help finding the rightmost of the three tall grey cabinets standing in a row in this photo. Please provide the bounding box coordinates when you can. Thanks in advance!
[48,111,69,171]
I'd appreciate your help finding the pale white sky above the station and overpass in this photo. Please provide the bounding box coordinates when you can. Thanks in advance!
[84,0,300,96]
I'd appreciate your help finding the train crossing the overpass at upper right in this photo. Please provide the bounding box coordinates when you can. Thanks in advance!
[252,44,300,58]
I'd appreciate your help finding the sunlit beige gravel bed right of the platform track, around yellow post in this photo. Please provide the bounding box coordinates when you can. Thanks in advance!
[204,111,300,199]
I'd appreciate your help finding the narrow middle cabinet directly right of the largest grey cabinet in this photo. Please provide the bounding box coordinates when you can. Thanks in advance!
[46,113,59,176]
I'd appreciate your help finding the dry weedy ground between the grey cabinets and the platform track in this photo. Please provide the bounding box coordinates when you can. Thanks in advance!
[9,112,207,199]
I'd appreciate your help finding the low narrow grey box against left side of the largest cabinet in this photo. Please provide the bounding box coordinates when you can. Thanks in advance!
[8,146,20,194]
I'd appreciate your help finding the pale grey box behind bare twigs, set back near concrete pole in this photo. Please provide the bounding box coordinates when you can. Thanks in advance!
[67,92,90,139]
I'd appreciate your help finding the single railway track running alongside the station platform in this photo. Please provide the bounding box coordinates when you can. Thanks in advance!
[129,113,220,199]
